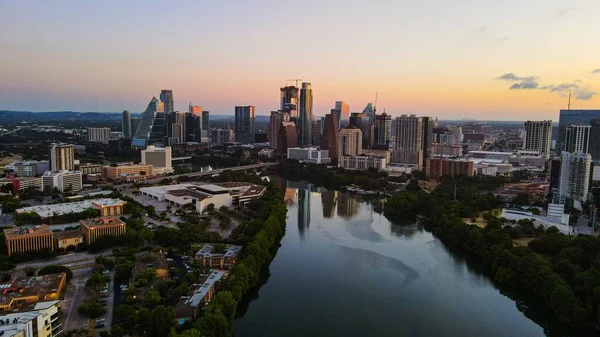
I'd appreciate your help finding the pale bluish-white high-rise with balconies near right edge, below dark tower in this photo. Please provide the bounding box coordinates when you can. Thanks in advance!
[558,151,592,210]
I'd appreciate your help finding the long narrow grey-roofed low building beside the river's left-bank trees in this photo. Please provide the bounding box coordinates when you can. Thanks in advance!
[173,270,227,326]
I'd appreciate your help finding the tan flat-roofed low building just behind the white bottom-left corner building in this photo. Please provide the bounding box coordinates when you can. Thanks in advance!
[0,273,67,311]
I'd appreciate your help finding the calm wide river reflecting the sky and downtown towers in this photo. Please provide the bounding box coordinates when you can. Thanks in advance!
[235,182,593,337]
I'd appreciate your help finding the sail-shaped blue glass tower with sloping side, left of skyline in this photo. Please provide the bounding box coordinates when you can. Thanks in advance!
[131,97,165,148]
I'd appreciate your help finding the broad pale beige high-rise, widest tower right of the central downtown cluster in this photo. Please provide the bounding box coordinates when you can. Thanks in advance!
[392,115,425,169]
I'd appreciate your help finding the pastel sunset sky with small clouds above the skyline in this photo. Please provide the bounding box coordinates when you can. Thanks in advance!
[0,0,600,120]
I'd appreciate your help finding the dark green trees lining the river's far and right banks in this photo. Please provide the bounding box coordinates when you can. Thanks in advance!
[278,162,600,330]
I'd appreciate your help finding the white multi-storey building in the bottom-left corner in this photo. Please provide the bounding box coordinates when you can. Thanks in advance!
[0,301,63,337]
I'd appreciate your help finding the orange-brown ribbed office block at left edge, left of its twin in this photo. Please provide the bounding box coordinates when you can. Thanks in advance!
[4,225,54,256]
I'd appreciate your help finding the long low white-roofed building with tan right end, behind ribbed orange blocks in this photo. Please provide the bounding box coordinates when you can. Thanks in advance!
[15,198,125,219]
